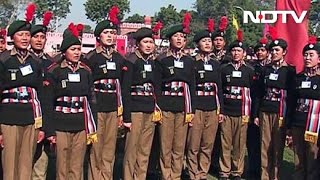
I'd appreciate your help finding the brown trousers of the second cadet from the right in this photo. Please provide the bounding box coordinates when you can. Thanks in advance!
[259,112,286,180]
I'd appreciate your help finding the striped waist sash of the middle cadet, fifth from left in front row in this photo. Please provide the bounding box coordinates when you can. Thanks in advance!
[162,81,192,123]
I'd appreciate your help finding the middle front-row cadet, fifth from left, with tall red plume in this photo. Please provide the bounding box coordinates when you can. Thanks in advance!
[156,13,195,180]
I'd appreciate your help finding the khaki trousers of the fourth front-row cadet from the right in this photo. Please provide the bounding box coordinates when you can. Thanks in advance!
[187,110,219,179]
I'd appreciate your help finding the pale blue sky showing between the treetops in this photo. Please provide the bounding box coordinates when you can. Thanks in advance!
[59,0,195,30]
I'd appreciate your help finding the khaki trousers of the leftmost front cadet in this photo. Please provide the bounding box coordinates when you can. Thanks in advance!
[1,124,39,180]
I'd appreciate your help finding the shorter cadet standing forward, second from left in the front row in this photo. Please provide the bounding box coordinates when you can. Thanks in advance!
[48,23,97,180]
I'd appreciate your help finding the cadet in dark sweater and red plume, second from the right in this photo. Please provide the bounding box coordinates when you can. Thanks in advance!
[254,28,295,180]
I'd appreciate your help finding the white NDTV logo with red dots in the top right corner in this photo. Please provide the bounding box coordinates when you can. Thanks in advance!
[243,11,308,24]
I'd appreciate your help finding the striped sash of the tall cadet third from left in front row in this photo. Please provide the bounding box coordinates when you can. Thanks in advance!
[93,79,123,116]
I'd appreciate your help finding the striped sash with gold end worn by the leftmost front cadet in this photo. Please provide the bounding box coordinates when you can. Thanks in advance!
[2,86,42,129]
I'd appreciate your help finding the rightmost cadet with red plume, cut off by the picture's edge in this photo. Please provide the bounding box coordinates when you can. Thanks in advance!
[289,36,320,180]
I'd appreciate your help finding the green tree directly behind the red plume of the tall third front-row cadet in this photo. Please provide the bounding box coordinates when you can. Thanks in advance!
[84,0,130,22]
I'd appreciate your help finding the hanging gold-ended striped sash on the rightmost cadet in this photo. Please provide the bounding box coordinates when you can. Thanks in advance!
[304,99,320,144]
